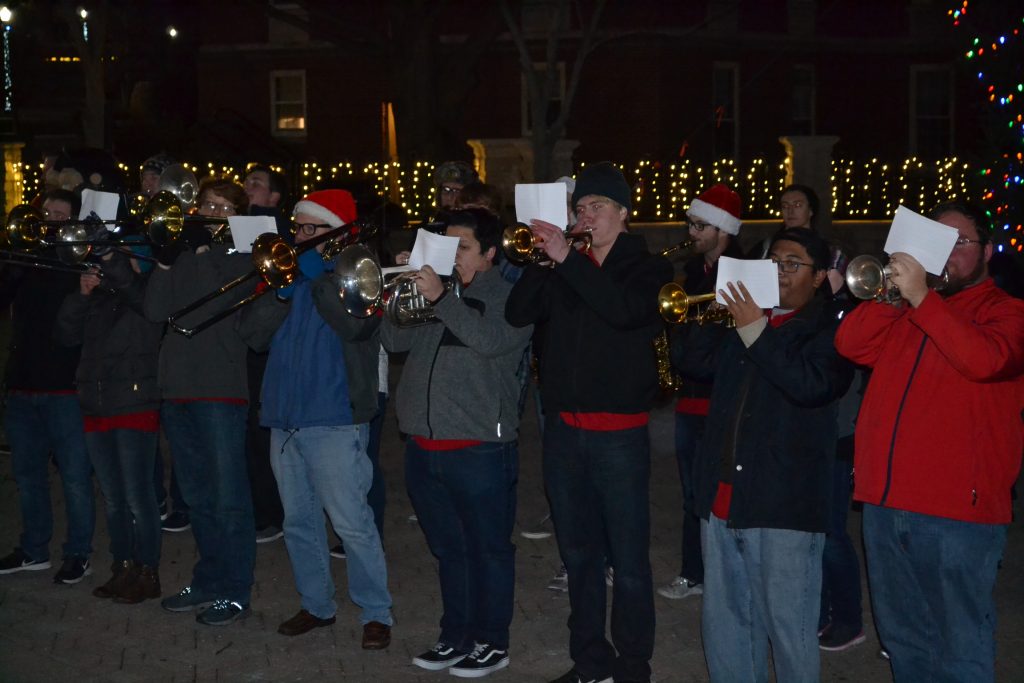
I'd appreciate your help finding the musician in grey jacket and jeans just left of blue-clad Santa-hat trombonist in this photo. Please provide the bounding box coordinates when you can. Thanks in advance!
[144,178,256,626]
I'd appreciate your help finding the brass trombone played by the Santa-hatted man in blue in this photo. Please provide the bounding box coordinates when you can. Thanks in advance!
[167,221,376,338]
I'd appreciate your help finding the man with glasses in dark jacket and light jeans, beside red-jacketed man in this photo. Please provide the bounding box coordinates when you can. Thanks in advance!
[673,228,851,683]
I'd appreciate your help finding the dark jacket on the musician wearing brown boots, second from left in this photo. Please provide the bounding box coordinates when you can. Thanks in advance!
[56,259,164,416]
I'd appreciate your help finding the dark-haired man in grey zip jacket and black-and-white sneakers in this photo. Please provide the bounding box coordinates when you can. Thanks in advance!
[382,209,532,678]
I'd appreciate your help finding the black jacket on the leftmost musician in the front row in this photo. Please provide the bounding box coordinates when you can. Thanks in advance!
[0,260,80,391]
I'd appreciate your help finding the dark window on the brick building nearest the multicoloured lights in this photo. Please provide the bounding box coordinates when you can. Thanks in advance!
[909,65,953,159]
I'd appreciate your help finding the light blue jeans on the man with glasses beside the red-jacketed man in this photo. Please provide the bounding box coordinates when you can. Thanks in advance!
[700,515,824,683]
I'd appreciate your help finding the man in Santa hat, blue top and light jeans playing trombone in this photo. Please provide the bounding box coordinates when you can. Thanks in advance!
[240,189,392,649]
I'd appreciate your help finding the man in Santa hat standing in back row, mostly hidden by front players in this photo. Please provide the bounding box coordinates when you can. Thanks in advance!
[657,183,743,600]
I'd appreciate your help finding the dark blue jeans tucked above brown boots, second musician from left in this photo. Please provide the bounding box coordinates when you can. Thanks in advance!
[85,429,160,567]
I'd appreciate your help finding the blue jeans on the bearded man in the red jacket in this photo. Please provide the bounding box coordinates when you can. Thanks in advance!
[864,504,1007,683]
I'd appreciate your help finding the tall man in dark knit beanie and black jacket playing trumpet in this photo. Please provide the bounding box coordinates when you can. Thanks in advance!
[506,163,672,683]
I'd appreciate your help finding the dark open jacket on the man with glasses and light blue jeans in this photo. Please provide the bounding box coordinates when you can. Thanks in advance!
[672,295,852,531]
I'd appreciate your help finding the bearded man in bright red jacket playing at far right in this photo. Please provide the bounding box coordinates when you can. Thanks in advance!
[836,203,1024,681]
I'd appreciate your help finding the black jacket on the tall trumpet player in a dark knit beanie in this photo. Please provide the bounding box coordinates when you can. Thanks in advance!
[505,232,672,414]
